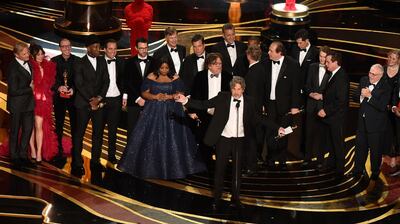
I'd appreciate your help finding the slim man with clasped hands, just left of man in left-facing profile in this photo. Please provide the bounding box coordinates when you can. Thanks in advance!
[303,46,330,166]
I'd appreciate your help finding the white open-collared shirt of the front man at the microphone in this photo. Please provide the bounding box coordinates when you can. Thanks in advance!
[221,96,244,138]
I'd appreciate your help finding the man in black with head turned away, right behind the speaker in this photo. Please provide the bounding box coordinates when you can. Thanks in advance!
[245,45,266,173]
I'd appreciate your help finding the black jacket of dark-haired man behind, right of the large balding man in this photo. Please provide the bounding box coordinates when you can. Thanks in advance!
[291,45,319,89]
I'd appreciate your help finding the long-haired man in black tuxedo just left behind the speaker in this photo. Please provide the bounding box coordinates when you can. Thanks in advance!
[189,53,232,168]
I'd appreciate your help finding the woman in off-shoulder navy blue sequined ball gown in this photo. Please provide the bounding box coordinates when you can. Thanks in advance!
[117,58,206,179]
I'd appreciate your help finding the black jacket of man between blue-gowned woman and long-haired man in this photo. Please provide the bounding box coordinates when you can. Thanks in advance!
[179,53,204,93]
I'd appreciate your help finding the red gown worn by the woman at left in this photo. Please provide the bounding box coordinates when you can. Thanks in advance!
[30,59,58,161]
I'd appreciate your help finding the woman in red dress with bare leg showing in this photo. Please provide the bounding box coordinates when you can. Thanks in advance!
[29,44,58,162]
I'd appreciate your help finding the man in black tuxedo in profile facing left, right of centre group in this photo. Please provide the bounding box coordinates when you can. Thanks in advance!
[318,51,349,177]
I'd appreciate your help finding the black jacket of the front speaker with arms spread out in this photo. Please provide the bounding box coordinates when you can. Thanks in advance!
[185,92,278,146]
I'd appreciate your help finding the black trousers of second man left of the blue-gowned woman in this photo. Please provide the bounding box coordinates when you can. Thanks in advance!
[103,96,122,158]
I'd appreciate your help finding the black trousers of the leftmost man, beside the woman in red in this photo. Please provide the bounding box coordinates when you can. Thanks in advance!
[9,111,33,160]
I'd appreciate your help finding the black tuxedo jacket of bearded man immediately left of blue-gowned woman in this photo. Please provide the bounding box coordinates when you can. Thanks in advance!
[123,55,154,106]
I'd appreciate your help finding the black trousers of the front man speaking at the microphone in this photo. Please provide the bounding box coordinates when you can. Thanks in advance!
[214,136,244,201]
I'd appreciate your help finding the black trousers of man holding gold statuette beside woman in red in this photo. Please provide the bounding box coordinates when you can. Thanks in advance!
[54,96,76,154]
